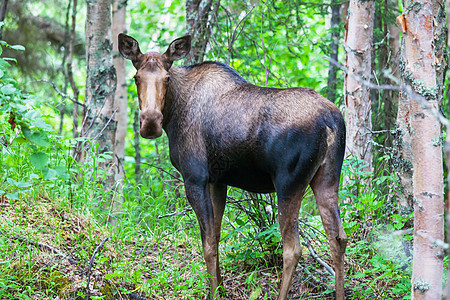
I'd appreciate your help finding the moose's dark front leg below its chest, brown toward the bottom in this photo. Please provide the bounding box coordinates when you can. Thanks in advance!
[185,182,226,299]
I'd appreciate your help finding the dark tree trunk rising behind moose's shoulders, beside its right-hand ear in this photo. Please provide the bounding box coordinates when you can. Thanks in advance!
[186,0,220,64]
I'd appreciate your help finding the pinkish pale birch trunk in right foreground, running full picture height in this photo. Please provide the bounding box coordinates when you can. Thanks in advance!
[399,0,445,300]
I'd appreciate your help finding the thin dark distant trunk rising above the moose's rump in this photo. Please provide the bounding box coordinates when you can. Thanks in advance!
[327,0,341,103]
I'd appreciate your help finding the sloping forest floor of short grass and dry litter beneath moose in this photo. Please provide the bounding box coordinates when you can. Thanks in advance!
[0,195,401,300]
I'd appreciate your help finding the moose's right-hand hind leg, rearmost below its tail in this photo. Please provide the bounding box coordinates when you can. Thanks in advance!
[311,166,348,300]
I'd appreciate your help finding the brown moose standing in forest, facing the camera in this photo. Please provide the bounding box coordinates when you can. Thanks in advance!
[118,33,347,299]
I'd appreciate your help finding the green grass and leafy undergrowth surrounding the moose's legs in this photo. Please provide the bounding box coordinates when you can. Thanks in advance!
[0,117,418,299]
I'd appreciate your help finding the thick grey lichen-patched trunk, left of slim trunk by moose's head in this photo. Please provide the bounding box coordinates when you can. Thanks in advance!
[82,0,118,185]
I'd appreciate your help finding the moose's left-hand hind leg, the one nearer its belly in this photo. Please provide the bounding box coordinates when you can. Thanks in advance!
[278,187,305,300]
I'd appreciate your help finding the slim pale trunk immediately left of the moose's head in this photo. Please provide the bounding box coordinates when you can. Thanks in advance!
[112,0,128,219]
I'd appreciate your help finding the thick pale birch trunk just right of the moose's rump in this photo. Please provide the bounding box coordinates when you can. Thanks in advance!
[344,0,375,171]
